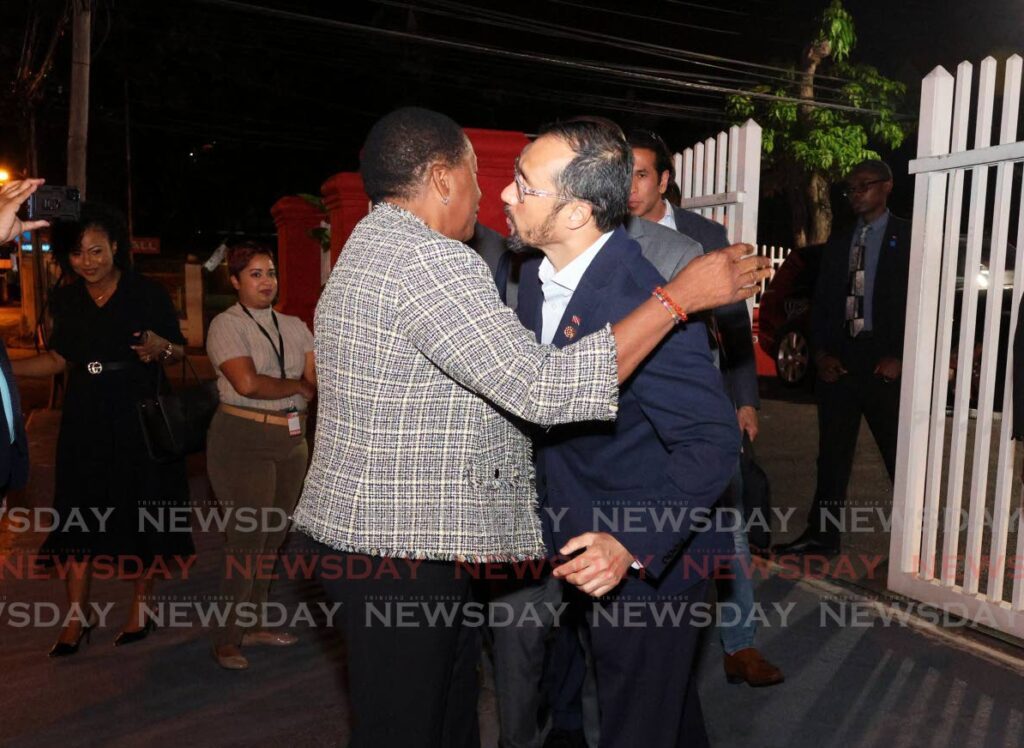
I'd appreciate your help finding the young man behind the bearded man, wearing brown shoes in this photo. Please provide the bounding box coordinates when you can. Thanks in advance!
[629,130,783,687]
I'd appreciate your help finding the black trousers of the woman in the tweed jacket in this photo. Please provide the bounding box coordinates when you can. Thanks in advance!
[314,543,480,748]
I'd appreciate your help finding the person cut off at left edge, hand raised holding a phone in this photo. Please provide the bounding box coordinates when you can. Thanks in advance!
[0,179,47,498]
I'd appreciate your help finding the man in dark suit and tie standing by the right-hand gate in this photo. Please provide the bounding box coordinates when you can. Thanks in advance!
[778,160,910,553]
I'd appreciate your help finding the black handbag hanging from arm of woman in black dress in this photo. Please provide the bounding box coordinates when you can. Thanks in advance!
[135,357,220,462]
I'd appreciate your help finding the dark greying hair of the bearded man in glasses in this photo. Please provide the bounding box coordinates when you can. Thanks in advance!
[541,119,633,232]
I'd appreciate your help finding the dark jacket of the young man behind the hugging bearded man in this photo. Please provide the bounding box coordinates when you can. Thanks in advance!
[672,208,761,408]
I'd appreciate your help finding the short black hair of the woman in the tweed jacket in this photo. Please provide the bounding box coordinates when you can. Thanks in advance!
[359,107,468,203]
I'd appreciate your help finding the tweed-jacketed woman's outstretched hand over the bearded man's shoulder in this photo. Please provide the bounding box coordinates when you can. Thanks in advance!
[665,244,771,315]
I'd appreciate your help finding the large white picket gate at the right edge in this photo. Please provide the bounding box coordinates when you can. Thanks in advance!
[889,55,1024,638]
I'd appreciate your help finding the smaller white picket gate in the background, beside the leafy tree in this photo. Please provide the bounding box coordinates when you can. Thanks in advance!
[673,120,761,246]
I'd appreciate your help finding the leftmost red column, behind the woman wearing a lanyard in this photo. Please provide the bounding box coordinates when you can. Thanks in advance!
[270,197,327,327]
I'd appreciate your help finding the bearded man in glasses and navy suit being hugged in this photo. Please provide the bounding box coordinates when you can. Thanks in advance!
[502,121,739,748]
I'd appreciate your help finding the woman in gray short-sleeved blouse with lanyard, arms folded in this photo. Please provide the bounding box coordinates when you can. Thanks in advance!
[206,242,316,670]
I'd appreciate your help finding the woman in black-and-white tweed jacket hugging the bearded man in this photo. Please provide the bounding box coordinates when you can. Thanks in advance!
[295,108,761,747]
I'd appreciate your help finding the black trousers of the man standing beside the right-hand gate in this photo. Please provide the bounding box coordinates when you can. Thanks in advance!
[807,361,900,544]
